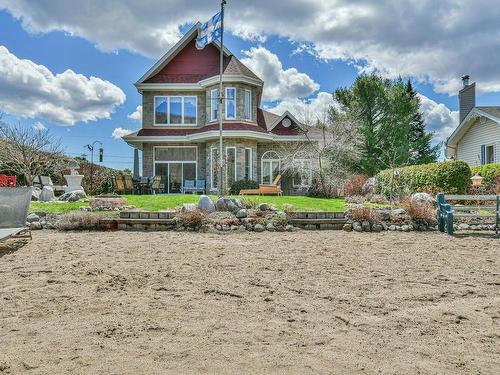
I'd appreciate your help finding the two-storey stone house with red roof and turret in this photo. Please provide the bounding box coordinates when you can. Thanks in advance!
[123,25,311,194]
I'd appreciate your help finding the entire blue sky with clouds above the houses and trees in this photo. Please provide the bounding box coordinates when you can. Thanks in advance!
[0,0,500,169]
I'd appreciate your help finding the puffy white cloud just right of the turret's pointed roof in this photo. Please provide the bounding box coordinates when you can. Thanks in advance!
[241,47,319,101]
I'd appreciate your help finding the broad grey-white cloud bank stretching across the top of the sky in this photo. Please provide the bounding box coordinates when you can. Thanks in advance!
[0,0,500,95]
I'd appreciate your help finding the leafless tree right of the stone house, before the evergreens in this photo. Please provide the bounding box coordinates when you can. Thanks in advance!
[280,98,360,197]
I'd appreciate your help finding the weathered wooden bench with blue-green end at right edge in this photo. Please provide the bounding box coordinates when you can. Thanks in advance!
[437,193,500,235]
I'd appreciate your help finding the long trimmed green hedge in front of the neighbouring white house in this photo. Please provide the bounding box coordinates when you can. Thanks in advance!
[376,160,471,196]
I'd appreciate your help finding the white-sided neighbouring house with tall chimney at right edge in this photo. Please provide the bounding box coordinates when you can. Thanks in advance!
[446,76,500,166]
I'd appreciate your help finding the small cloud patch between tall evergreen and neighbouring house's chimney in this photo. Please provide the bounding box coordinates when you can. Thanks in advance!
[418,94,458,142]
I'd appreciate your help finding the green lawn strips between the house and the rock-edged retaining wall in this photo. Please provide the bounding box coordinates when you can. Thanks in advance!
[30,194,346,214]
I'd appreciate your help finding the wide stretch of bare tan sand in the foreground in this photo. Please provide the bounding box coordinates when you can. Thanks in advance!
[0,231,500,374]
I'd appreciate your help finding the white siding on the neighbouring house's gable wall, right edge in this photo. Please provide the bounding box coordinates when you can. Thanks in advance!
[456,117,500,166]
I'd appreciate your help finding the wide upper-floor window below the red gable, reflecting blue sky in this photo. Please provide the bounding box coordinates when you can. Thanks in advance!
[154,96,198,125]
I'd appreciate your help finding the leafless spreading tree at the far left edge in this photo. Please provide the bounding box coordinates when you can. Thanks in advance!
[0,121,63,185]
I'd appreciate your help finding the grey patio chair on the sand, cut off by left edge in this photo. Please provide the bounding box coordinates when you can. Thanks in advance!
[0,187,33,242]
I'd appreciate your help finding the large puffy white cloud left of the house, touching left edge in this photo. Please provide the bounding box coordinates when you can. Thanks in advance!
[0,46,125,126]
